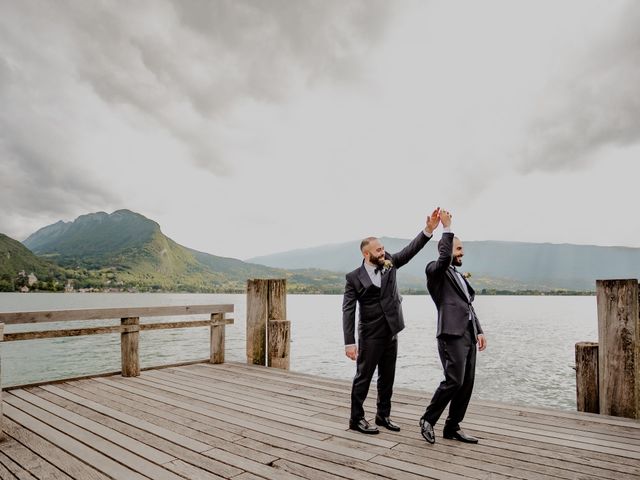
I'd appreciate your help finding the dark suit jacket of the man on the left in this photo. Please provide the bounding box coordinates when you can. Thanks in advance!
[342,232,431,345]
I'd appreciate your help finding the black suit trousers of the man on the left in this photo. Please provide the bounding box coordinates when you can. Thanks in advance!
[351,335,398,421]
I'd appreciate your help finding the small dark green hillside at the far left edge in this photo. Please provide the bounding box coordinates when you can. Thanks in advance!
[0,233,65,291]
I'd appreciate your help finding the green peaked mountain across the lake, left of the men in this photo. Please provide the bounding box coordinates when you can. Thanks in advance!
[24,210,342,292]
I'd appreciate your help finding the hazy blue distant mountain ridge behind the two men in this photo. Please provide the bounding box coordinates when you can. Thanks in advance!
[247,234,640,291]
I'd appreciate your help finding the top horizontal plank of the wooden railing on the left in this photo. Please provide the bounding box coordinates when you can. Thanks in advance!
[0,304,234,325]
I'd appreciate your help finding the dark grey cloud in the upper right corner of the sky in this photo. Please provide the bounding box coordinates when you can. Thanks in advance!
[518,2,640,172]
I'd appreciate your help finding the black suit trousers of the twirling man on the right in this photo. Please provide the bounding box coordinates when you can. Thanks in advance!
[423,322,476,431]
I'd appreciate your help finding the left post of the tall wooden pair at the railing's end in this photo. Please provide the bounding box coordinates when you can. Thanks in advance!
[247,279,269,365]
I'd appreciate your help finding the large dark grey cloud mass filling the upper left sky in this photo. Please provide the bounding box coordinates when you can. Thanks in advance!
[0,0,390,221]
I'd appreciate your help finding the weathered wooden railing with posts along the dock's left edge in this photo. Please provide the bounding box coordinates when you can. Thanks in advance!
[0,305,234,440]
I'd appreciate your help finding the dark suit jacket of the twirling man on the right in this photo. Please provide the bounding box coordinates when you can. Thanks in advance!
[426,233,483,337]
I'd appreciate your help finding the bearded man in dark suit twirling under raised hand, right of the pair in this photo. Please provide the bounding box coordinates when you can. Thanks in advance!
[420,210,487,444]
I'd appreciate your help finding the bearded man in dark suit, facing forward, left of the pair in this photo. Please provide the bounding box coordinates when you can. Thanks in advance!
[342,209,440,434]
